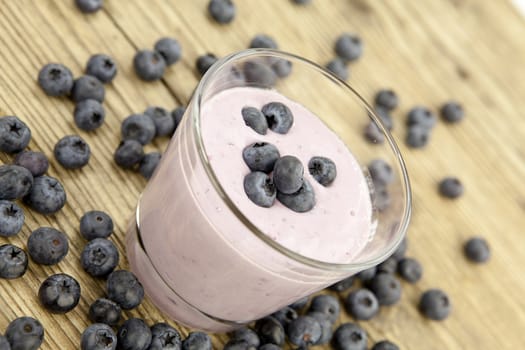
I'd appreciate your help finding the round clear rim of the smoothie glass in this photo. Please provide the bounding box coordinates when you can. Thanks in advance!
[191,49,412,271]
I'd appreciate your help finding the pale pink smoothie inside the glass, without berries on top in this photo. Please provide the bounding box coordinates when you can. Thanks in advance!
[128,87,373,331]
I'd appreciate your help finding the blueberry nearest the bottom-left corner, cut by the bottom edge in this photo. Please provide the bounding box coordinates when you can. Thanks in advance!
[5,316,44,350]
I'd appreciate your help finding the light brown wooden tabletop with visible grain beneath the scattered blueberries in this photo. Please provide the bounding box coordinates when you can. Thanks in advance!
[0,0,525,349]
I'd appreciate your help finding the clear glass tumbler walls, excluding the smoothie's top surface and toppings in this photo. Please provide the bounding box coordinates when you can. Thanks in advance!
[126,49,411,332]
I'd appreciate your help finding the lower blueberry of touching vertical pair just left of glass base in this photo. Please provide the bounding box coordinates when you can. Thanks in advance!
[80,238,119,278]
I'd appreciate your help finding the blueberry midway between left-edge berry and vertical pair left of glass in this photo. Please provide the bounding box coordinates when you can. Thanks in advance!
[27,227,69,265]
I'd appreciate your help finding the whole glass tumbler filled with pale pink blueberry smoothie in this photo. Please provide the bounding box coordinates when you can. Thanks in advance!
[126,49,411,332]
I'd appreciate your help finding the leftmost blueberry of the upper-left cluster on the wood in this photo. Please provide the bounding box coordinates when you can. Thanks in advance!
[38,63,73,96]
